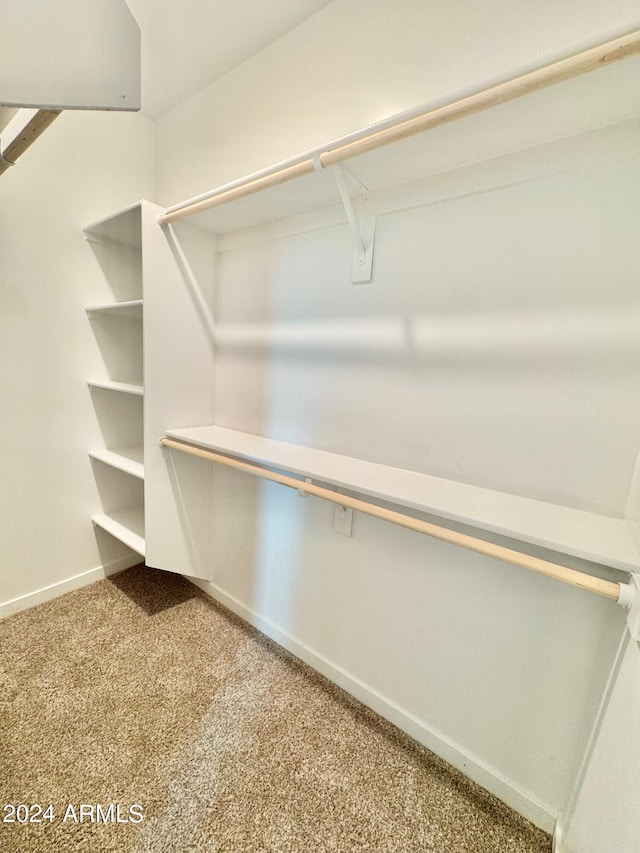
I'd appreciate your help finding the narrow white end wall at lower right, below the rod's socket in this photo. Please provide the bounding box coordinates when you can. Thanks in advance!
[557,628,640,853]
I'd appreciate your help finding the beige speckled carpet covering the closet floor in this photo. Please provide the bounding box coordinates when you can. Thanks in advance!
[0,566,551,853]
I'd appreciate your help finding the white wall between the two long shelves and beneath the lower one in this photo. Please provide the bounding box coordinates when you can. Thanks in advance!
[198,140,640,819]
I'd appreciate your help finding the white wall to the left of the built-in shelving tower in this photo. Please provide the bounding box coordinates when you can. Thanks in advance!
[0,113,153,614]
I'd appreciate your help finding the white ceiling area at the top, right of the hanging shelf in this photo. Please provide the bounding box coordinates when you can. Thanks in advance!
[127,0,331,118]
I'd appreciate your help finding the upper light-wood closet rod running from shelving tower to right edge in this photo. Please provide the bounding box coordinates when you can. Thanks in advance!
[159,30,640,224]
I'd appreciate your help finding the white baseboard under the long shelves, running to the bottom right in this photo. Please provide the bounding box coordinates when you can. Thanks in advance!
[186,577,557,833]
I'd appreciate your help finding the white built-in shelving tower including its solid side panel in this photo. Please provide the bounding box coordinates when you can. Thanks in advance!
[84,200,214,577]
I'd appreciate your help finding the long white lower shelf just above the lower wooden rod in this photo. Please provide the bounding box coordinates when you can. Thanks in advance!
[167,426,640,571]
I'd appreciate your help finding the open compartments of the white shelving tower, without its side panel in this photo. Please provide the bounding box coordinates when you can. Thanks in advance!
[84,203,145,557]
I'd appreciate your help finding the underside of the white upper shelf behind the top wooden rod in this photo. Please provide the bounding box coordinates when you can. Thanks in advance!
[178,51,640,234]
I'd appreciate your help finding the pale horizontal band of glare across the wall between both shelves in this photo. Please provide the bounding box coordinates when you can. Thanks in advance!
[216,305,637,371]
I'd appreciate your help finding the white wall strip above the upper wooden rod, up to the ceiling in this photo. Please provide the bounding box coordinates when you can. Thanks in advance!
[156,0,640,205]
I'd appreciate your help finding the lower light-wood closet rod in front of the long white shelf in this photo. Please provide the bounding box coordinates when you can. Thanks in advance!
[160,438,629,604]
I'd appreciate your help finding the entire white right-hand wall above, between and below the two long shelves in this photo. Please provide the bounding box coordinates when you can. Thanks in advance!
[156,0,640,829]
